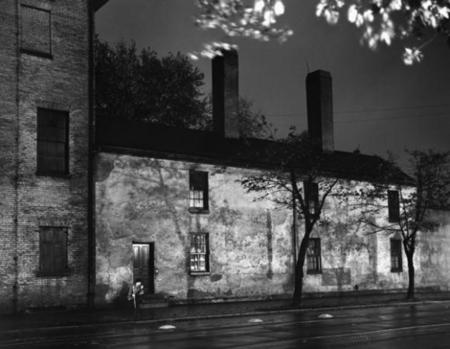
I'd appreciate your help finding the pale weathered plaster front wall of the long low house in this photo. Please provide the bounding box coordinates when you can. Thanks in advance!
[96,153,450,302]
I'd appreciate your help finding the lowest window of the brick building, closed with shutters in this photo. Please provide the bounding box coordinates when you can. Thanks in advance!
[37,226,70,278]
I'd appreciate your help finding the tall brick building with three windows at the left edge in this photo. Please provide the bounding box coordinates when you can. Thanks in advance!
[0,0,105,310]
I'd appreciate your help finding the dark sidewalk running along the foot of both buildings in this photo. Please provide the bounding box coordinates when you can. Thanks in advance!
[0,292,450,333]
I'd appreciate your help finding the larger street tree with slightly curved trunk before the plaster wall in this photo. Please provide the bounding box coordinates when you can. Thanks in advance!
[241,129,344,306]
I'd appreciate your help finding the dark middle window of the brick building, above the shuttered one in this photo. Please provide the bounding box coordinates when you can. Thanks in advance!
[37,108,69,175]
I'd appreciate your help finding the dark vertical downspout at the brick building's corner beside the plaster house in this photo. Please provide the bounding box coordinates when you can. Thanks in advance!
[86,0,96,308]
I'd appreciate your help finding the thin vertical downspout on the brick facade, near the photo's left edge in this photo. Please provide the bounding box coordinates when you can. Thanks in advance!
[12,0,20,313]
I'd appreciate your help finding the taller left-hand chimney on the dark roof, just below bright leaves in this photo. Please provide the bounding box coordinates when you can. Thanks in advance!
[212,50,240,138]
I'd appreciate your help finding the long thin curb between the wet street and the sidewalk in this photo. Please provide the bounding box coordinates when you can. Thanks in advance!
[0,300,450,335]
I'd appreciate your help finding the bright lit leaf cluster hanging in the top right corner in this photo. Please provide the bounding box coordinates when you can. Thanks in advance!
[316,0,450,65]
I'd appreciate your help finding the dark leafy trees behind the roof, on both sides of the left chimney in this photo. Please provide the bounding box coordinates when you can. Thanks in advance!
[95,39,275,138]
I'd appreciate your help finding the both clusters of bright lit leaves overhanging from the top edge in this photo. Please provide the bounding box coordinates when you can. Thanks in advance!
[193,0,450,65]
